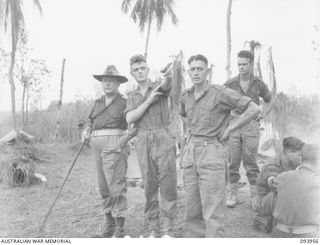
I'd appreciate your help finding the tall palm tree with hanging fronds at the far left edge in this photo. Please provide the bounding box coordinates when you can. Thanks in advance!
[0,0,42,129]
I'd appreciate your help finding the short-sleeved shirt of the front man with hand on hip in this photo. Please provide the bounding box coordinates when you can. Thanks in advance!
[180,84,251,137]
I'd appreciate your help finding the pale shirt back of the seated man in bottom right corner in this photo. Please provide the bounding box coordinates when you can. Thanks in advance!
[273,166,320,226]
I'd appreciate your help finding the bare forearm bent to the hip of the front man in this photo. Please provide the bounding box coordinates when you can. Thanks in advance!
[221,102,261,141]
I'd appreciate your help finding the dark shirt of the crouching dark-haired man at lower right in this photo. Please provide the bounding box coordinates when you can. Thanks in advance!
[257,155,286,195]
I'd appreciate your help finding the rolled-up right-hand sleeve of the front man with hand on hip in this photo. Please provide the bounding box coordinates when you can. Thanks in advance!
[219,87,252,113]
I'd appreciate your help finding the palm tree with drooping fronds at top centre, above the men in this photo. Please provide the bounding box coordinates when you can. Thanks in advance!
[121,0,178,59]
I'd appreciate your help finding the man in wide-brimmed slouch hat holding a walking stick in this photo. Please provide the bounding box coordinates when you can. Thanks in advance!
[83,65,134,237]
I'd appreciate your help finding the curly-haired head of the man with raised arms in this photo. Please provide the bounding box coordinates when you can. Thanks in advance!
[130,54,149,83]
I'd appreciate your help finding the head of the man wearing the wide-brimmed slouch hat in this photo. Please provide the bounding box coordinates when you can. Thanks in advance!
[93,65,128,96]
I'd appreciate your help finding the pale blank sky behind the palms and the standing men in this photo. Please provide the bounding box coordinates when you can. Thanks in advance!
[0,0,320,111]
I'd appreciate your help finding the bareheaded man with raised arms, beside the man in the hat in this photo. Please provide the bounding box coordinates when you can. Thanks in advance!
[126,55,177,237]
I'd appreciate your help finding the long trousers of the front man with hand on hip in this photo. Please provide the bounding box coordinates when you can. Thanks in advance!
[182,137,228,238]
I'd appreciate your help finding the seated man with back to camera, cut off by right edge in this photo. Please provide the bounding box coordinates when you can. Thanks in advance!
[272,144,320,238]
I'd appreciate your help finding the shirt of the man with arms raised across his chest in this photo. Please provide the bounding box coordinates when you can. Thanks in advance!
[125,81,171,129]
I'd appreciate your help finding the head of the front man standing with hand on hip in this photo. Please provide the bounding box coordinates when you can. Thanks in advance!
[188,54,210,85]
